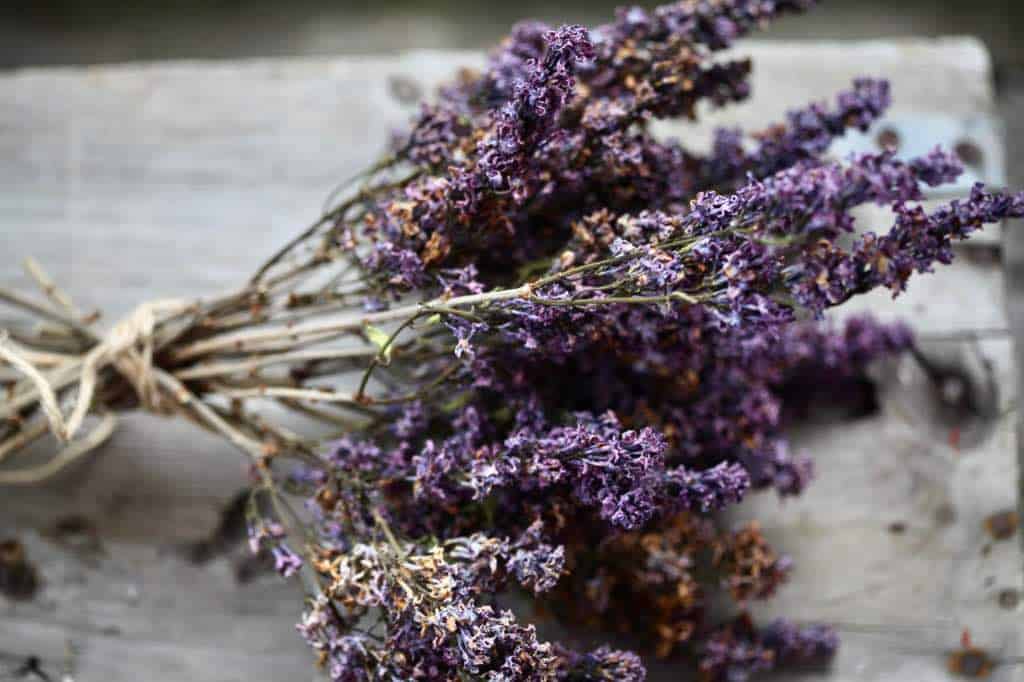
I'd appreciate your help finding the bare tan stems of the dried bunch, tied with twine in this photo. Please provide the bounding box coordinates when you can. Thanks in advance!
[0,173,503,484]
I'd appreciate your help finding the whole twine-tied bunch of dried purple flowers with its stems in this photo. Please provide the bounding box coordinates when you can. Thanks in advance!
[0,0,1024,681]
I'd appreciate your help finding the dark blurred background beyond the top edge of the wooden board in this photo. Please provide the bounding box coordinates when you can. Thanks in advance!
[0,0,1024,184]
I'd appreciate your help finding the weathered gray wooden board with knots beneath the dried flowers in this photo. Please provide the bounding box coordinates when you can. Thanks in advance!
[0,39,1024,681]
